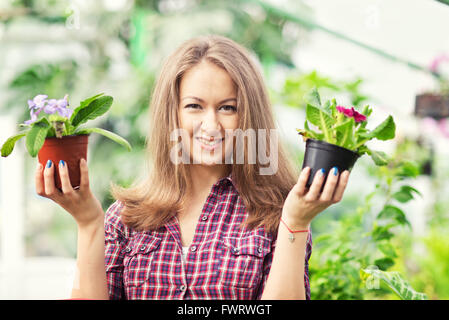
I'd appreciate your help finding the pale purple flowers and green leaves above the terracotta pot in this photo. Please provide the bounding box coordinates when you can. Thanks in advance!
[1,93,131,157]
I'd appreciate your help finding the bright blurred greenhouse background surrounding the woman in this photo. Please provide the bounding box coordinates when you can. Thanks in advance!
[0,0,449,300]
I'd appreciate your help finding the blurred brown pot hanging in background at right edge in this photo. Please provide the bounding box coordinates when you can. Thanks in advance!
[415,93,449,119]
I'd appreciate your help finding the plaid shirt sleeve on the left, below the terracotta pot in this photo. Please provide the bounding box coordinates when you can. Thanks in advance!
[104,201,126,300]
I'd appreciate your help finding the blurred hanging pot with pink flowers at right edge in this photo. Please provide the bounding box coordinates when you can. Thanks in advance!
[415,54,449,120]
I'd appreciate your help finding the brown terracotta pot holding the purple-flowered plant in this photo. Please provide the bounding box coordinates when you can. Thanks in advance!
[38,135,89,190]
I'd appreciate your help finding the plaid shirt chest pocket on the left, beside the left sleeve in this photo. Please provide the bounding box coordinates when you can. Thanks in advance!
[123,233,161,287]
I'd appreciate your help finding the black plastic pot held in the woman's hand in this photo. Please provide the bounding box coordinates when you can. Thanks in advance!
[302,139,360,190]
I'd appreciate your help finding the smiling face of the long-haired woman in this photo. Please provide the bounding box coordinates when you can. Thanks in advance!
[178,61,238,169]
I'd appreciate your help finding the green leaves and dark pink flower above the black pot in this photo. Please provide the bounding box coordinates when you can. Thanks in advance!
[296,89,396,165]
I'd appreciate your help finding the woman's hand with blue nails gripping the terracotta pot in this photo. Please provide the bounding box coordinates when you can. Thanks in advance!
[35,159,104,227]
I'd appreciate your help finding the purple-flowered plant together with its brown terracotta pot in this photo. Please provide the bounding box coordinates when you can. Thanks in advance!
[1,93,131,190]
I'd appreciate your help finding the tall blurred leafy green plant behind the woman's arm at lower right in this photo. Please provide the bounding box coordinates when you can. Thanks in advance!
[310,155,428,300]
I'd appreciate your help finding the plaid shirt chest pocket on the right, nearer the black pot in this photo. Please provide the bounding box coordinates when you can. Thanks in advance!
[220,235,271,288]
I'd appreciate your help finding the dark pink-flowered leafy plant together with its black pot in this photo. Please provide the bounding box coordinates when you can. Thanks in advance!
[296,89,396,187]
